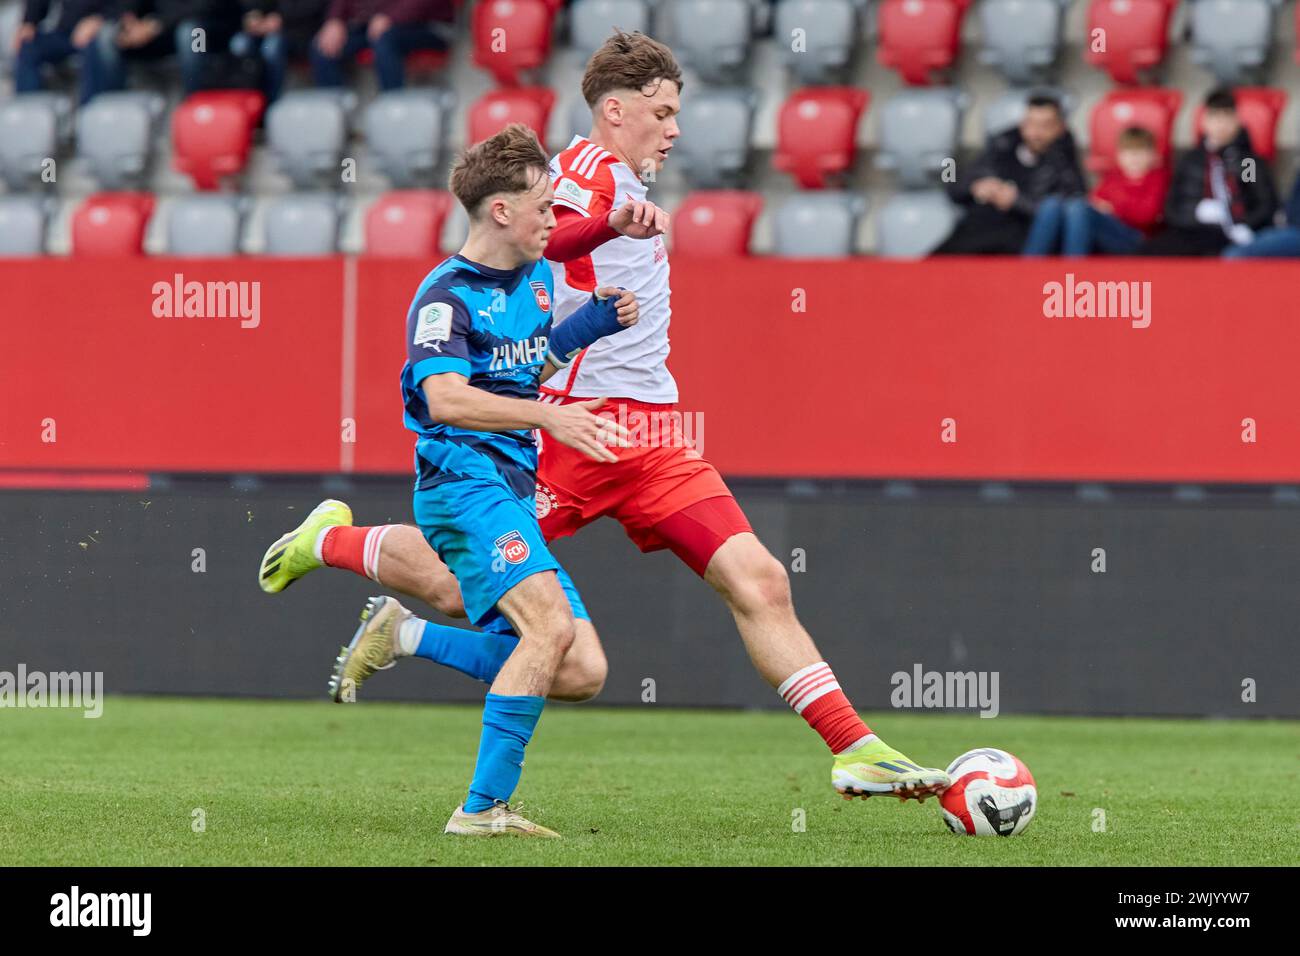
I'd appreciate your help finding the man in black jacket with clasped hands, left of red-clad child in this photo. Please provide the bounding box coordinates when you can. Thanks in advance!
[935,95,1084,255]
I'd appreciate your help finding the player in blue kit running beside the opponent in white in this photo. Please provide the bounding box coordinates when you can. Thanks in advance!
[374,124,637,836]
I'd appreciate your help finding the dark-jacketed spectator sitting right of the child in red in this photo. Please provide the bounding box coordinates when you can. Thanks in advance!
[1139,88,1278,256]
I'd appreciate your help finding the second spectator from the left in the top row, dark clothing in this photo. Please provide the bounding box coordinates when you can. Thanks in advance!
[94,0,241,94]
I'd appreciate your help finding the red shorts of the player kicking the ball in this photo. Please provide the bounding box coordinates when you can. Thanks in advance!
[537,395,750,576]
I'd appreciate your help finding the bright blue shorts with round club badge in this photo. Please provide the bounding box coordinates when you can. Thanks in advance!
[413,477,590,633]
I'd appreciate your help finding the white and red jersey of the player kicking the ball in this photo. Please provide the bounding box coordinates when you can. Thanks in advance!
[546,137,677,403]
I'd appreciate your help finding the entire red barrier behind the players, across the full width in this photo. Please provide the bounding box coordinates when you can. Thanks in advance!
[0,259,1300,483]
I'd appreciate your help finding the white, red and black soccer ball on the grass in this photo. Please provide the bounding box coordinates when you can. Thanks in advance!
[939,747,1039,836]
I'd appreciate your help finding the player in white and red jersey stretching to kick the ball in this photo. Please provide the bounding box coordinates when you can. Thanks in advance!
[263,33,949,800]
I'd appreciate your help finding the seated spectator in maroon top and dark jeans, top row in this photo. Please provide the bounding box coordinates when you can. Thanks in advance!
[312,0,455,90]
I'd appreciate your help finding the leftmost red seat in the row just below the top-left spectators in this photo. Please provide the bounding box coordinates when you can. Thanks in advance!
[172,90,267,190]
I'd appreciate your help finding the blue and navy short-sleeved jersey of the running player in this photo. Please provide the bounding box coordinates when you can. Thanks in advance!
[402,255,553,499]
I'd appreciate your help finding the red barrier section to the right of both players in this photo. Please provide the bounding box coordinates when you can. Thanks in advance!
[670,259,1300,481]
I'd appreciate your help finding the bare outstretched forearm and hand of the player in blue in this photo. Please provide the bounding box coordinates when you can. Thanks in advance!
[420,372,632,462]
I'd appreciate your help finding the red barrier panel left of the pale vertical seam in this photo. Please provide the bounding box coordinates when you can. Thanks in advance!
[0,259,343,471]
